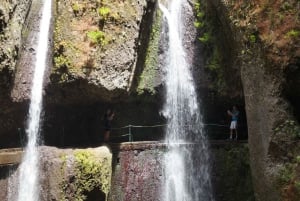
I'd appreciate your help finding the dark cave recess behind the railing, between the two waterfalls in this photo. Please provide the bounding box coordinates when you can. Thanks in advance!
[42,101,165,147]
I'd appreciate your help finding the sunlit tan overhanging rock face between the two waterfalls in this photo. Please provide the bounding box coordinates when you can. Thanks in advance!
[47,0,155,103]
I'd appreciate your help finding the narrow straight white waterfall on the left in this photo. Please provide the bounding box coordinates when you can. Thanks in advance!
[18,0,52,201]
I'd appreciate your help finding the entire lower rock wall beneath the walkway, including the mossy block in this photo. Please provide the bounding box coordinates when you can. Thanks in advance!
[0,141,254,201]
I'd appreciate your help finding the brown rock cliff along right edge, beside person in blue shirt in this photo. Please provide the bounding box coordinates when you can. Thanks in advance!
[210,0,300,201]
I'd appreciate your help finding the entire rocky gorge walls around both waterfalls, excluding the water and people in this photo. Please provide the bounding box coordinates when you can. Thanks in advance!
[0,0,300,201]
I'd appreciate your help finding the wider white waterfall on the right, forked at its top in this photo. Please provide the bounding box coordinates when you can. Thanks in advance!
[159,0,213,201]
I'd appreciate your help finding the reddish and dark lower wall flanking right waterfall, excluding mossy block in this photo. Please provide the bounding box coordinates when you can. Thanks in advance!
[109,142,255,201]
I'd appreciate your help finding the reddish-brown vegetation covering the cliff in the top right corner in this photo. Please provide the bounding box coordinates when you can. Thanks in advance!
[224,0,300,67]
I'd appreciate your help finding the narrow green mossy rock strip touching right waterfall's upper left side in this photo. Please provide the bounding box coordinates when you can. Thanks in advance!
[137,10,162,94]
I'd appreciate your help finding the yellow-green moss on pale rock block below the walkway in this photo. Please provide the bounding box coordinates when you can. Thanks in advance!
[60,148,112,201]
